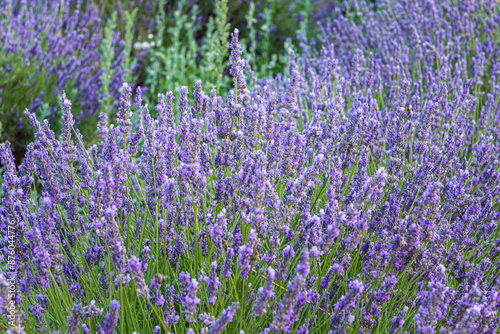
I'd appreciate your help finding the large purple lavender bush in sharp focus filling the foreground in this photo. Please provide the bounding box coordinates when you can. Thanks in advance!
[0,0,500,333]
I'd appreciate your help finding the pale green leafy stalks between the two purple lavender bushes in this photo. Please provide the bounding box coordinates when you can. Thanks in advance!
[139,0,313,102]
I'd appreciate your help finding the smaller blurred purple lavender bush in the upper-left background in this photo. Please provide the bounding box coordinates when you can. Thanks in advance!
[0,0,135,158]
